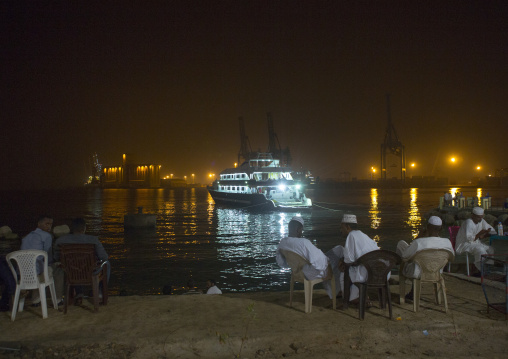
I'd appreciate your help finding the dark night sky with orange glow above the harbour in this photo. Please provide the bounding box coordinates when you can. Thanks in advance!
[0,0,508,189]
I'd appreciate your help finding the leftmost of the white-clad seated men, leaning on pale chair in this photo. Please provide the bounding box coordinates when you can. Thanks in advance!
[276,216,339,298]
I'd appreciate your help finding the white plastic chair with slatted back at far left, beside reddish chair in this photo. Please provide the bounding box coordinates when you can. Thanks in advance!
[6,249,58,321]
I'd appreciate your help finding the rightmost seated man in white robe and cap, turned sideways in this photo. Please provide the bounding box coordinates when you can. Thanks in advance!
[455,207,496,270]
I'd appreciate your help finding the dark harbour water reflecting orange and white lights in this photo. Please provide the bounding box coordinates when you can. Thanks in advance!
[0,188,508,294]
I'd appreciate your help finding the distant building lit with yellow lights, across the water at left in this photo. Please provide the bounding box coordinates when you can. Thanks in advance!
[101,154,161,188]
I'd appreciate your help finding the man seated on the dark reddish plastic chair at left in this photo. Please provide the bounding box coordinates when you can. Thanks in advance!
[53,218,111,298]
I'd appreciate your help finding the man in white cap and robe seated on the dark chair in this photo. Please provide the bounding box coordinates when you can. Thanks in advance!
[332,214,379,301]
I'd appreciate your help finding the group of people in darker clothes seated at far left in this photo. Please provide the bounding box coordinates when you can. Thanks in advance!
[0,215,111,311]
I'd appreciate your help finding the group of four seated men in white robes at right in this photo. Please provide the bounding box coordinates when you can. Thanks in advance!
[276,207,495,303]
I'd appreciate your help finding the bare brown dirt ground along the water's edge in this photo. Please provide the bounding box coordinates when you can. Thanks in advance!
[0,275,508,359]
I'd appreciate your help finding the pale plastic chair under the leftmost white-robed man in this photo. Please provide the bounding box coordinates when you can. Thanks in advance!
[281,250,337,313]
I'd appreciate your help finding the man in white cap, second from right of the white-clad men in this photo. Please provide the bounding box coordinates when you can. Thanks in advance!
[396,216,455,279]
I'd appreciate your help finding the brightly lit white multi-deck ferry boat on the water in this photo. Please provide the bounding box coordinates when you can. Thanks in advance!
[208,153,312,210]
